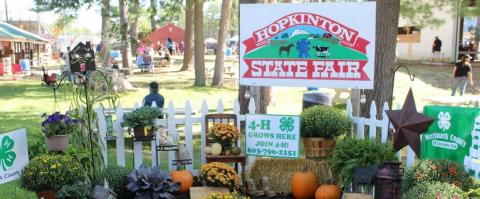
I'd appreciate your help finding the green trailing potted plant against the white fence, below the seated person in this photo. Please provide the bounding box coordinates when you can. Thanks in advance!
[121,106,162,140]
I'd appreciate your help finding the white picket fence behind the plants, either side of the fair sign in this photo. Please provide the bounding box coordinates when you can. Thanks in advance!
[95,99,415,174]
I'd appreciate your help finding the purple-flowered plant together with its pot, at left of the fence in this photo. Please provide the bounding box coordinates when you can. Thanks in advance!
[42,112,78,151]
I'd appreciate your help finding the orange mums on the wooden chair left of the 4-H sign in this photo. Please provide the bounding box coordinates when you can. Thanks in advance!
[208,123,240,155]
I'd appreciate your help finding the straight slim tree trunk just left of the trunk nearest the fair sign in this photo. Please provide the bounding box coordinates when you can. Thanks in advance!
[194,0,205,86]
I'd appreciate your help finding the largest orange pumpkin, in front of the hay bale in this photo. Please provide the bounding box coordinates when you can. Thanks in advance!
[290,169,318,199]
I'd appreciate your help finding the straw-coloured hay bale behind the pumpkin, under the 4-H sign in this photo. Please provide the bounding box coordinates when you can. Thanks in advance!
[250,158,332,193]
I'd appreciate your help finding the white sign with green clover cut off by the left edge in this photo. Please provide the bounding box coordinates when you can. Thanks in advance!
[0,129,28,184]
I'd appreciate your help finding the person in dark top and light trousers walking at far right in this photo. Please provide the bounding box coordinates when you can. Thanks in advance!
[452,54,473,96]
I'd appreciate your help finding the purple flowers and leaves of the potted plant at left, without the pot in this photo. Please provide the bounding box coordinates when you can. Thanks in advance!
[42,112,78,137]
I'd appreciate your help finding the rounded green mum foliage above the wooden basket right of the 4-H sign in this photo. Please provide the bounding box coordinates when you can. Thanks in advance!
[301,106,352,139]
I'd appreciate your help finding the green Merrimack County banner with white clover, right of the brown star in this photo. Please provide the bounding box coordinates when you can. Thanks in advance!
[421,106,480,178]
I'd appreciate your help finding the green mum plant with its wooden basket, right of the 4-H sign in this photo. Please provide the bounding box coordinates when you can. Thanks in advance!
[300,106,352,158]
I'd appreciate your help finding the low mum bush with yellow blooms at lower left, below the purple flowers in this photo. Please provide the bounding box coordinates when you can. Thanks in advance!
[21,155,85,191]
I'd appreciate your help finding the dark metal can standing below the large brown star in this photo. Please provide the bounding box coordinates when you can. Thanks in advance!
[375,162,403,199]
